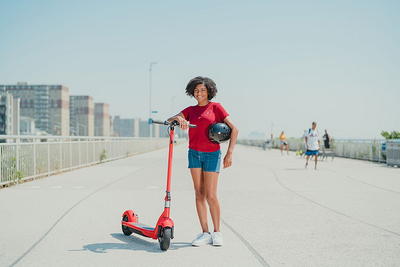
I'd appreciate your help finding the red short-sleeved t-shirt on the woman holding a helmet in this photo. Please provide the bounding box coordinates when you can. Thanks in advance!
[181,102,229,152]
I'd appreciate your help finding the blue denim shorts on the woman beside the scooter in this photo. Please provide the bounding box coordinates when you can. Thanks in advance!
[188,148,221,172]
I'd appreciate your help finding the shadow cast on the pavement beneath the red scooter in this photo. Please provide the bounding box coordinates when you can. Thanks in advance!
[80,233,192,253]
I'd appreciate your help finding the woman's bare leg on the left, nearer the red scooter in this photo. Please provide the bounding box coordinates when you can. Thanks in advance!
[190,168,208,232]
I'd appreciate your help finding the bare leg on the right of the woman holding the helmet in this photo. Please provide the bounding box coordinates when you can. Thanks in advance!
[203,172,221,232]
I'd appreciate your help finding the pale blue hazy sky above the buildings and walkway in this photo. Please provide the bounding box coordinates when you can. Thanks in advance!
[0,0,400,139]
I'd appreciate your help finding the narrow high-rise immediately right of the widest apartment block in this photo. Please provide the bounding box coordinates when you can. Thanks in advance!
[69,95,94,136]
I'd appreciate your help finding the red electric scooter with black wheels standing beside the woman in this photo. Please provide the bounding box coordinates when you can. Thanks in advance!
[121,120,196,250]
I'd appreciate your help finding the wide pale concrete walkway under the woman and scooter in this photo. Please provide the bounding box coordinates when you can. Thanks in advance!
[0,145,400,267]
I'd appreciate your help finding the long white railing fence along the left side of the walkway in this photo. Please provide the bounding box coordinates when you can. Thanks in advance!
[0,135,172,185]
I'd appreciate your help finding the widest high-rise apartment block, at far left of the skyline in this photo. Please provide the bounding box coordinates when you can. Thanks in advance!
[0,83,69,135]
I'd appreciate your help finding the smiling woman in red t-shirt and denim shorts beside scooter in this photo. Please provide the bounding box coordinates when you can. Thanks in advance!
[168,77,238,246]
